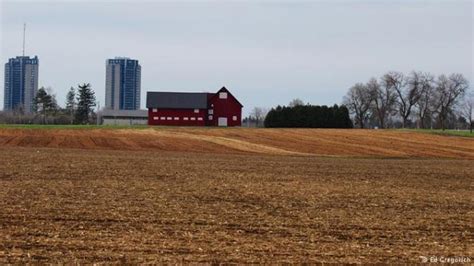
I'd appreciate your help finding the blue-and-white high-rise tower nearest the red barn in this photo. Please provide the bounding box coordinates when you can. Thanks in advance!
[105,57,141,110]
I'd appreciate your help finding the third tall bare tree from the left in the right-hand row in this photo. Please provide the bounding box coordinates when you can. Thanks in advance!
[388,71,423,128]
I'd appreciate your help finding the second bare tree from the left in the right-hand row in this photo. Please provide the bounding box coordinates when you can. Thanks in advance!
[367,75,397,128]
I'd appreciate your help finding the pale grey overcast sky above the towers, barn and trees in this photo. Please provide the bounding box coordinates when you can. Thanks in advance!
[0,0,474,114]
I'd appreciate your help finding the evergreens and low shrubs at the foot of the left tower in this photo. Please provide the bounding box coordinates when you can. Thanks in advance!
[0,83,97,124]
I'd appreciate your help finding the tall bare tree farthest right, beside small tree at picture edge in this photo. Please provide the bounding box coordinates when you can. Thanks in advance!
[433,74,469,130]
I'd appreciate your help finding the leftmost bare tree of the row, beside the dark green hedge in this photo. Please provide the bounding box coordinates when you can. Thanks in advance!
[343,83,371,128]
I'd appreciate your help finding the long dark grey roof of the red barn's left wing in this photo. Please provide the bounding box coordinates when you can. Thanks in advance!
[146,92,207,109]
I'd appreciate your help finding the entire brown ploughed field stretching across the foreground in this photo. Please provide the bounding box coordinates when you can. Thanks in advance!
[0,128,474,263]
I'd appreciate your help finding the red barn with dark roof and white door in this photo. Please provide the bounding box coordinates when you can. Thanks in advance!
[146,87,243,127]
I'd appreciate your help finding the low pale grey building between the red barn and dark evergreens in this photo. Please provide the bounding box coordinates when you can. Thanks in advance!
[98,109,148,126]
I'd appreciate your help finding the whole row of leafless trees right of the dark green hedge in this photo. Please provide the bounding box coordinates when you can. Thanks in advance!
[343,71,474,132]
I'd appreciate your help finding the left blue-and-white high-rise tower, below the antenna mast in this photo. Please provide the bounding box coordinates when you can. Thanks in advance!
[3,56,38,113]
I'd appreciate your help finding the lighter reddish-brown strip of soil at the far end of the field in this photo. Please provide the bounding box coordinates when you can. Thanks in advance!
[0,128,474,159]
